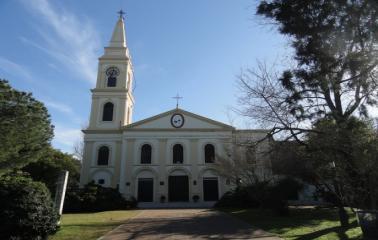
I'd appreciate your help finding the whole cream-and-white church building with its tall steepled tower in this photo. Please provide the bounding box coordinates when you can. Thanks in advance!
[80,15,270,203]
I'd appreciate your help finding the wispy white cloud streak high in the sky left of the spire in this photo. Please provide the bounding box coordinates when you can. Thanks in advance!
[21,0,101,84]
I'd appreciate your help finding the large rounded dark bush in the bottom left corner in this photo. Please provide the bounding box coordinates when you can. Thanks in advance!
[0,175,58,240]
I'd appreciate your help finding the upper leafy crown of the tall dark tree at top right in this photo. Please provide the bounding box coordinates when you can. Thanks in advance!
[257,0,378,122]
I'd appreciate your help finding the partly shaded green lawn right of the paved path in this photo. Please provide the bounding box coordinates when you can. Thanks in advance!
[223,208,362,240]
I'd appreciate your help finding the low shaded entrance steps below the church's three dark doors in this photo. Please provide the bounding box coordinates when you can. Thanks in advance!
[138,202,216,209]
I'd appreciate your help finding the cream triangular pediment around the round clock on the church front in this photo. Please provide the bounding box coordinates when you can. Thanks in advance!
[124,108,234,130]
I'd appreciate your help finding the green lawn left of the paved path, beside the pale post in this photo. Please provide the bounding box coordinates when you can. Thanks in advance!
[49,210,138,240]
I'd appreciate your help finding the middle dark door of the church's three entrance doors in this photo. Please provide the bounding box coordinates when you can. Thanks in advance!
[168,176,189,202]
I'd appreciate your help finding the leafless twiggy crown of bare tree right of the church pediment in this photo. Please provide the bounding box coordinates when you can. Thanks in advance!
[236,62,320,144]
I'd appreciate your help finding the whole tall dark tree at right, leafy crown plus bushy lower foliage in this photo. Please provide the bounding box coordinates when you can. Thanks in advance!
[251,0,378,226]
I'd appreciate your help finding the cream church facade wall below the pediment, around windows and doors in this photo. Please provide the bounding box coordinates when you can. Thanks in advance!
[81,130,267,202]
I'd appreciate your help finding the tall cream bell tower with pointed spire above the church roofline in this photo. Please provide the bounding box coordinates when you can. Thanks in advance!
[88,10,134,130]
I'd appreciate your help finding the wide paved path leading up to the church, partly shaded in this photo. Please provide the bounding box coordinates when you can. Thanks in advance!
[100,209,280,240]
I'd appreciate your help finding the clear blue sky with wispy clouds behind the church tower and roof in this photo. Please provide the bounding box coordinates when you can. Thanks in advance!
[0,0,290,152]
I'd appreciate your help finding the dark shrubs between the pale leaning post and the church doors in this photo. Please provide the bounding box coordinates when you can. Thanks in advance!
[64,183,137,212]
